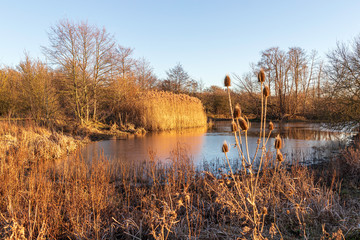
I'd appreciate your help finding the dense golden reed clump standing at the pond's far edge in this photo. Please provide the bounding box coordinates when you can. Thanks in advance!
[129,91,207,131]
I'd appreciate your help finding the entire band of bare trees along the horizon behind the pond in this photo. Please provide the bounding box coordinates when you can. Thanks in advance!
[0,20,360,124]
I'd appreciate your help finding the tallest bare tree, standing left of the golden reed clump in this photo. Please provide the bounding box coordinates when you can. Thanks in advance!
[43,20,115,122]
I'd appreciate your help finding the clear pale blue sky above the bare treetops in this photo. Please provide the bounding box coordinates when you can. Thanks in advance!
[0,0,360,86]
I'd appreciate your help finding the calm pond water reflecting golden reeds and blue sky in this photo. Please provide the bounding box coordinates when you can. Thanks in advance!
[82,121,353,166]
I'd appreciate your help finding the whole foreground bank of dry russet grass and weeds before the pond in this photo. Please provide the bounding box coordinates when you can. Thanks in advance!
[0,124,360,239]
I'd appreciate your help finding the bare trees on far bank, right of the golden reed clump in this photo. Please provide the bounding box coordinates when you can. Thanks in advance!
[197,42,360,125]
